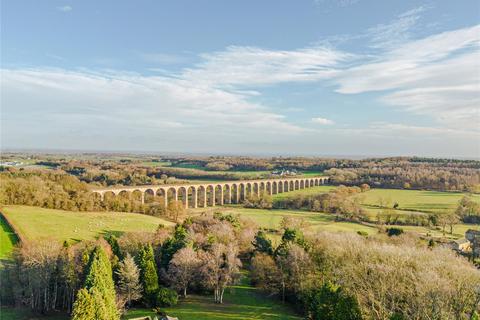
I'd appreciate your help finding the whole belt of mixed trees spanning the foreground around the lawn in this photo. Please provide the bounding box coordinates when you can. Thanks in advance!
[2,214,480,319]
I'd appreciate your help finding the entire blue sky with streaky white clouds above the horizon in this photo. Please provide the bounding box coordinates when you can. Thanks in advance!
[1,0,480,157]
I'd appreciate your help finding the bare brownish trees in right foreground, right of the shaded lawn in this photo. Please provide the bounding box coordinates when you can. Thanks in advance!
[251,226,480,320]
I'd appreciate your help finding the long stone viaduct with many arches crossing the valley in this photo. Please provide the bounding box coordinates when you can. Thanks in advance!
[92,177,329,208]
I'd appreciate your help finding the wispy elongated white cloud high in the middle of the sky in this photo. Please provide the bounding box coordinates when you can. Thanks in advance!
[181,46,351,87]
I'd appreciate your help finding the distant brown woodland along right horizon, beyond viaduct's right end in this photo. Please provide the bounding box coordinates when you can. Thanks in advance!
[169,157,480,192]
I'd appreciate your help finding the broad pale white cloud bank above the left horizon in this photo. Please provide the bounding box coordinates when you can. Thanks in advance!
[2,69,306,151]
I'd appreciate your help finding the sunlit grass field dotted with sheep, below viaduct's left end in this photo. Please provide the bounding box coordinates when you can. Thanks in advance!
[2,206,173,241]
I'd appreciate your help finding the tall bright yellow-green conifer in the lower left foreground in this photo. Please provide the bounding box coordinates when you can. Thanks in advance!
[72,246,120,320]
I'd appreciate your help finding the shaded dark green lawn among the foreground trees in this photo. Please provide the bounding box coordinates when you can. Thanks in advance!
[125,278,302,320]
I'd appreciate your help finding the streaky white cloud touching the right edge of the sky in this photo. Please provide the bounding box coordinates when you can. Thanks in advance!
[335,25,480,129]
